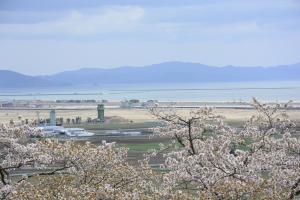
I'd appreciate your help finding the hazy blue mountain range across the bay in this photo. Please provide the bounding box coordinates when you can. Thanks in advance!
[0,62,300,88]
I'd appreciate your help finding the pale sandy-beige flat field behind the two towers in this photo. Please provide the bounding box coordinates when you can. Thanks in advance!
[0,108,300,123]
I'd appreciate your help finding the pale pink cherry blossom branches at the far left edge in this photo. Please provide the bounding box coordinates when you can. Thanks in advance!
[0,125,48,199]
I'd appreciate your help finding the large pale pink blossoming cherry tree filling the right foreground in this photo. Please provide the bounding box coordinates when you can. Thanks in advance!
[150,99,300,199]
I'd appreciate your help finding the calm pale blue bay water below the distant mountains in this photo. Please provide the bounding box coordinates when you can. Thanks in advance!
[0,81,300,102]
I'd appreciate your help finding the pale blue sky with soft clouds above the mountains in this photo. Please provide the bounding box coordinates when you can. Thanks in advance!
[0,0,300,75]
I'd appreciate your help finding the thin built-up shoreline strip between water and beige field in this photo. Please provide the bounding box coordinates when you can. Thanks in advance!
[0,99,300,110]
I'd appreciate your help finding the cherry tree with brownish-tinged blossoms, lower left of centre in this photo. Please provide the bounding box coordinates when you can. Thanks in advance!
[9,141,159,199]
